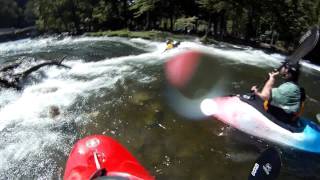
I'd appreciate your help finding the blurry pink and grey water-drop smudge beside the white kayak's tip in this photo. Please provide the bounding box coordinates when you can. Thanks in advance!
[164,51,228,120]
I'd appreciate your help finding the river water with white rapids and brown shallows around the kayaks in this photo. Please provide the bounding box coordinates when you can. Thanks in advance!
[0,37,320,180]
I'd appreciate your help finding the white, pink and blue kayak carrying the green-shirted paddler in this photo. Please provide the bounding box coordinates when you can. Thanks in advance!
[200,96,320,153]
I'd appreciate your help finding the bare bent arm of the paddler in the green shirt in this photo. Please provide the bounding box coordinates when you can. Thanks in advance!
[251,72,279,100]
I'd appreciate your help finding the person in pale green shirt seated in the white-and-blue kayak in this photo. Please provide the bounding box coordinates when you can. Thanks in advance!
[251,62,305,125]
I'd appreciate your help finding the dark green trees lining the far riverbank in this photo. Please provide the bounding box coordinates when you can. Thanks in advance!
[0,0,320,49]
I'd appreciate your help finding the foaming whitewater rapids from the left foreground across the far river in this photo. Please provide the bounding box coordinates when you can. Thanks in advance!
[0,37,313,179]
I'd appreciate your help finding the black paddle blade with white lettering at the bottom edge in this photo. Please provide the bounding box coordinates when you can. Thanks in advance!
[248,147,281,180]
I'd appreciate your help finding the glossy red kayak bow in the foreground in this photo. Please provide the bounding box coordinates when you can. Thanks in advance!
[63,135,155,180]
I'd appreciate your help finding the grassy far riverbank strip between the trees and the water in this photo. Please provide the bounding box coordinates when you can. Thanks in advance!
[0,29,290,58]
